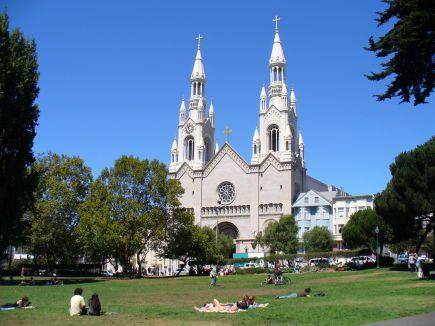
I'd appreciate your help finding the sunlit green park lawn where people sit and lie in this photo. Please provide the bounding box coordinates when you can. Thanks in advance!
[0,269,435,325]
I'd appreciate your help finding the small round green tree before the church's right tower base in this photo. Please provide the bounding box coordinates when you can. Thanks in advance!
[256,215,298,254]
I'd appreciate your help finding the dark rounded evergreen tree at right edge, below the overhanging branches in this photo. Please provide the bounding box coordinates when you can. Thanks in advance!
[375,137,435,252]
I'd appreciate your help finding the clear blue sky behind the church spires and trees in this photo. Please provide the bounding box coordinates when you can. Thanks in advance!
[4,0,435,194]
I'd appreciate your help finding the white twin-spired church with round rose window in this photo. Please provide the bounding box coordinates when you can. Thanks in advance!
[169,17,336,254]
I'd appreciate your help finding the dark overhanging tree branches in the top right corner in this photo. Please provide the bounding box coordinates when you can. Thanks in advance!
[367,0,435,106]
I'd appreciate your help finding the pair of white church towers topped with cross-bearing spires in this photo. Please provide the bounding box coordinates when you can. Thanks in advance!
[169,16,305,172]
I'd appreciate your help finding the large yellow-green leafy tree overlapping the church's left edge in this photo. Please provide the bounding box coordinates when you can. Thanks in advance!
[80,156,183,273]
